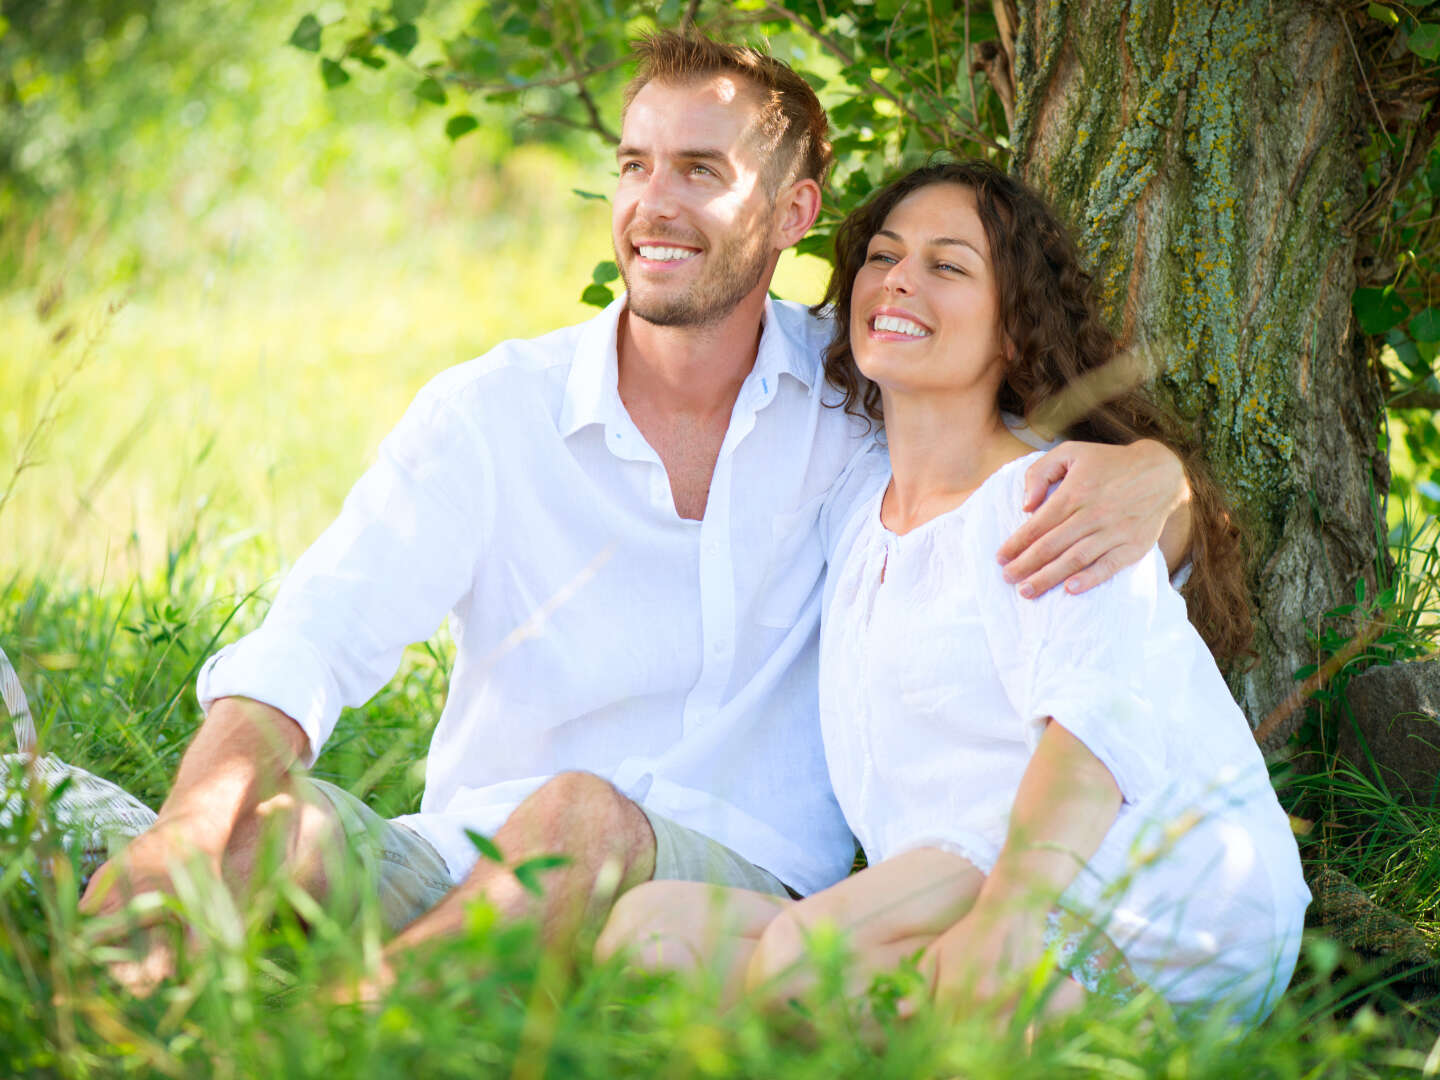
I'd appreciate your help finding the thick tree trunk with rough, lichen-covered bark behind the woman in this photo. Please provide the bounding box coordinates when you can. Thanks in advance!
[996,0,1388,747]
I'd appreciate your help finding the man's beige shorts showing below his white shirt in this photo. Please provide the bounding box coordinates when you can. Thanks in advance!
[311,780,792,933]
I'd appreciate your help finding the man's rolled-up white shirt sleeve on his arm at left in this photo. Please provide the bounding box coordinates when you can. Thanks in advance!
[197,376,494,765]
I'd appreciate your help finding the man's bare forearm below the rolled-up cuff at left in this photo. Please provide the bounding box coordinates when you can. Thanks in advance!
[156,697,310,857]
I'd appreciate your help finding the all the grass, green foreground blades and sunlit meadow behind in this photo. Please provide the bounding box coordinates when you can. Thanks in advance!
[0,157,1440,1080]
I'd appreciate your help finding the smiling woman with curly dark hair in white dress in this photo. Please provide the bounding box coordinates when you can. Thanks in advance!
[599,164,1309,1020]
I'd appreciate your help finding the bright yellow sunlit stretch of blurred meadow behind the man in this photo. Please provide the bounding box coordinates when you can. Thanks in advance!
[0,151,828,580]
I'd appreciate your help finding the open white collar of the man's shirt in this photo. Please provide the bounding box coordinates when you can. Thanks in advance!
[559,294,824,438]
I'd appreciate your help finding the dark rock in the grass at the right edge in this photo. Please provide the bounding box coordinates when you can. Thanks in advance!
[1338,660,1440,806]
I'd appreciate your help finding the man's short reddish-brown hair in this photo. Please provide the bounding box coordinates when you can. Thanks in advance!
[625,30,831,192]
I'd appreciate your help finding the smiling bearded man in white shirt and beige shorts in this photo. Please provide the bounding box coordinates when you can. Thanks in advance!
[75,35,1185,988]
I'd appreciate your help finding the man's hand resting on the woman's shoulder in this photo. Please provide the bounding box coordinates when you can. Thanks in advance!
[996,439,1189,598]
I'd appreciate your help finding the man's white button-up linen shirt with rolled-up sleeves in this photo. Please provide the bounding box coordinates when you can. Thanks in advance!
[199,297,870,893]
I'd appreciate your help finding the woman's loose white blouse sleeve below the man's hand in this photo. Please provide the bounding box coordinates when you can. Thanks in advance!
[963,458,1184,802]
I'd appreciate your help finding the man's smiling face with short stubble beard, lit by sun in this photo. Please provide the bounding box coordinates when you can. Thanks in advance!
[612,75,776,327]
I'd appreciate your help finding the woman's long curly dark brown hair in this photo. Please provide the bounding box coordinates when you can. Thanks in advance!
[814,161,1254,660]
